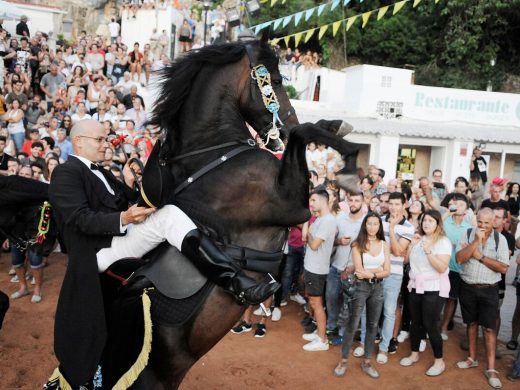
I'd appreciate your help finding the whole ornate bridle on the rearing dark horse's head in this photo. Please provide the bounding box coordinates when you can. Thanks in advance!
[246,44,296,150]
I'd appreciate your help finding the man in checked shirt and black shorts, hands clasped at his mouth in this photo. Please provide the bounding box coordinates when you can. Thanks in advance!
[457,208,509,388]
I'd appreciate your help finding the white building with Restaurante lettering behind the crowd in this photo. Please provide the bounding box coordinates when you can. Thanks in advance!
[282,65,520,186]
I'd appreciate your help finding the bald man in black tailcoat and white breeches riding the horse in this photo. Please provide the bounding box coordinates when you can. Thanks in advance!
[49,120,279,388]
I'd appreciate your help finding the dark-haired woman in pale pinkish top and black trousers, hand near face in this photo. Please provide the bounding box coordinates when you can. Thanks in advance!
[400,210,452,376]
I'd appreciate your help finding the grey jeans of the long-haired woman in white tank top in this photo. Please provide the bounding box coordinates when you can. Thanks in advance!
[341,280,383,359]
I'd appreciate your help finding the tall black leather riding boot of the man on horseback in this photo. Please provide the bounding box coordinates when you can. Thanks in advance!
[181,229,280,305]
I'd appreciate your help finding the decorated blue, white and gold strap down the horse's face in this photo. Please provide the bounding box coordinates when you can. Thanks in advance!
[251,64,284,150]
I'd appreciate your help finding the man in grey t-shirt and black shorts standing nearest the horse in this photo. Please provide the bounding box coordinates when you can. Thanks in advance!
[302,190,336,351]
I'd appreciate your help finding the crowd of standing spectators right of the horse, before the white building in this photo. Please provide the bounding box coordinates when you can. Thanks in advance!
[232,144,520,388]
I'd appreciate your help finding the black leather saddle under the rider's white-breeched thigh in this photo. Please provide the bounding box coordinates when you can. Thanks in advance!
[106,242,207,299]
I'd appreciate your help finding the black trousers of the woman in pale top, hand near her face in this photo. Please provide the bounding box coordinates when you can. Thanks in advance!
[409,289,445,359]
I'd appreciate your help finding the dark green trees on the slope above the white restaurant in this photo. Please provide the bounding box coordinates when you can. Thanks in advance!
[251,0,520,90]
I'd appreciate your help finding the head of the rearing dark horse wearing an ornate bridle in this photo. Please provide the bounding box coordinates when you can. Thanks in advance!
[240,34,298,150]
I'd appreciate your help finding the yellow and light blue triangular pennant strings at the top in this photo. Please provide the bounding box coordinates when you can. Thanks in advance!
[253,0,440,47]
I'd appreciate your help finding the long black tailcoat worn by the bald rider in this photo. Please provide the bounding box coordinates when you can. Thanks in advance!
[49,156,138,386]
